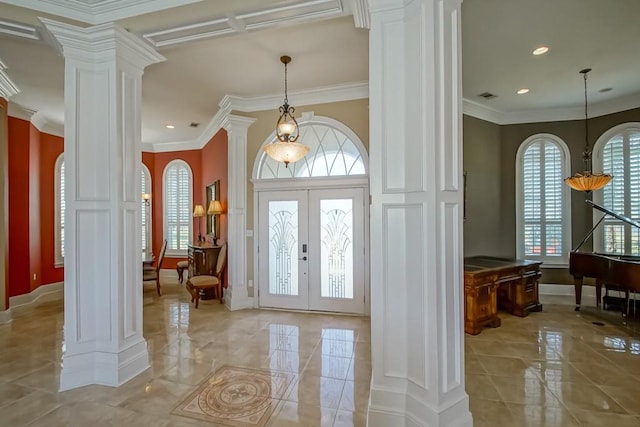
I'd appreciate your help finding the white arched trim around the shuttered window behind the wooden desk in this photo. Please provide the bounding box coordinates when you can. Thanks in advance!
[516,133,571,267]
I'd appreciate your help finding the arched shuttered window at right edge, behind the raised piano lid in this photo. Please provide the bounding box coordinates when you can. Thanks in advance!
[594,123,640,255]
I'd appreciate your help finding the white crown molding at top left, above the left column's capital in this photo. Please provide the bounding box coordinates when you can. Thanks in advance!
[2,0,202,25]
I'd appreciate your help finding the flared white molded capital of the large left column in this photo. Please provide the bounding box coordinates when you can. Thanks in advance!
[39,18,166,69]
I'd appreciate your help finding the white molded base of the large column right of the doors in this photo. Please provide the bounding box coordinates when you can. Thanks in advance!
[367,387,473,427]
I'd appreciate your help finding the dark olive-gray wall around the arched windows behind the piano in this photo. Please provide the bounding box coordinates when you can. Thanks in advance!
[463,108,640,283]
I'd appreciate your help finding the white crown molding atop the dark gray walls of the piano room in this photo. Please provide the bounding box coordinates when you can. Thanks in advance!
[462,93,640,125]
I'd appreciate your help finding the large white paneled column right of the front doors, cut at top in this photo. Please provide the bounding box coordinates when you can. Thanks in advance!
[368,0,472,427]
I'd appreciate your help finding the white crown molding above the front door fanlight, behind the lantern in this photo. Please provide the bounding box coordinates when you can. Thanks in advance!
[220,82,369,113]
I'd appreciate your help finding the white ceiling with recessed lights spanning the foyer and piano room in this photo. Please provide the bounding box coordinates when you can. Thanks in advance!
[0,0,640,148]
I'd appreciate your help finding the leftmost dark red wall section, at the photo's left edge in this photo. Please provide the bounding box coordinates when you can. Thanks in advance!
[7,117,32,297]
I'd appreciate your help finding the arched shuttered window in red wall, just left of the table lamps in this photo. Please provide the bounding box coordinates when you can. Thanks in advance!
[162,160,193,255]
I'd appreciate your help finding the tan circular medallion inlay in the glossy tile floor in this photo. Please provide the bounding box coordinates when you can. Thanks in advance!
[173,366,294,427]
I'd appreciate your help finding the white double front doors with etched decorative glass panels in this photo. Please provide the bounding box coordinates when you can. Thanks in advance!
[258,188,366,314]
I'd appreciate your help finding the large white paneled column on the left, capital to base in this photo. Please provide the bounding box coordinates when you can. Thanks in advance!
[42,19,164,390]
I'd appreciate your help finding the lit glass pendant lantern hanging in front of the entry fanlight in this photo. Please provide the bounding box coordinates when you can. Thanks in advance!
[264,56,309,167]
